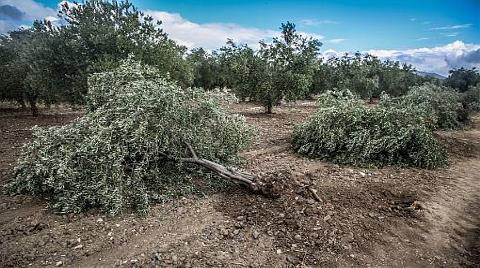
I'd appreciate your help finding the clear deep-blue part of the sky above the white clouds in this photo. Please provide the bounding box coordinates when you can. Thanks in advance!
[134,0,480,50]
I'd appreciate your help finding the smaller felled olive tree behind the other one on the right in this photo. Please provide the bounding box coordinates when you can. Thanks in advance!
[380,83,469,129]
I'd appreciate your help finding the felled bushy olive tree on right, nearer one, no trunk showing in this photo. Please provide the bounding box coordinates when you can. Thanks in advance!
[292,93,447,169]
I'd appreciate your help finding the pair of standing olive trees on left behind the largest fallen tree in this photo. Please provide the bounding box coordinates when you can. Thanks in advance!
[0,0,193,115]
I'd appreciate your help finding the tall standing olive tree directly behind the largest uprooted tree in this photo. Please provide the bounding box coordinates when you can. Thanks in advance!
[59,0,193,91]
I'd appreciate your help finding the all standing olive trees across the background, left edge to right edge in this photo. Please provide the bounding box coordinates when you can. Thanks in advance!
[0,0,480,115]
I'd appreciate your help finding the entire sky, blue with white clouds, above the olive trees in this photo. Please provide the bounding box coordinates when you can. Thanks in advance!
[0,0,480,74]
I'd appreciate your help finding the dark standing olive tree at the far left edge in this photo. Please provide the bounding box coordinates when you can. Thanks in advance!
[0,21,59,115]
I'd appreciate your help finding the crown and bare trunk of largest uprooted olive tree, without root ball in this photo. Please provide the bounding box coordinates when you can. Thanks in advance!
[7,60,253,214]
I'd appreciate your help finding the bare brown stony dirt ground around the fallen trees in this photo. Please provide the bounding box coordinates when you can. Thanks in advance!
[0,102,480,267]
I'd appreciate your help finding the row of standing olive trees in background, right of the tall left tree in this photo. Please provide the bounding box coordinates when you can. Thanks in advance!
[188,29,436,113]
